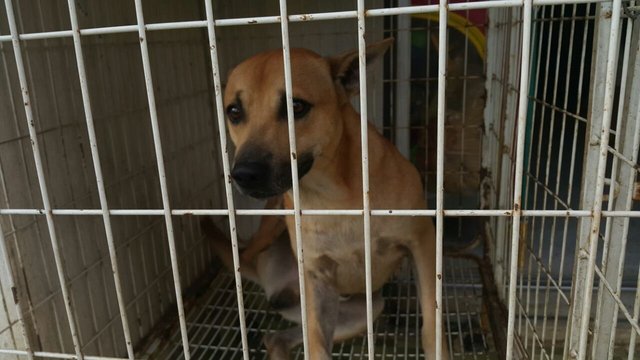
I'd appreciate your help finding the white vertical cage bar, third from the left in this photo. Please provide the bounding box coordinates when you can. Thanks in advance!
[130,0,191,360]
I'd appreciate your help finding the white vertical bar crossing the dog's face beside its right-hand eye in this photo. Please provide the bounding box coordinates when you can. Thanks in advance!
[280,0,310,360]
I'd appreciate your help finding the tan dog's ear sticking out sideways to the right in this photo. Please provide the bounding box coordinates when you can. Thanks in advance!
[328,38,394,97]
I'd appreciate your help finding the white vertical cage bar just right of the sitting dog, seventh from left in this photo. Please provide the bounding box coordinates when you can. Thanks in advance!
[432,0,449,360]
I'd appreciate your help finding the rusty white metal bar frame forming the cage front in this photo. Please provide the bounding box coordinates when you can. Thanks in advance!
[0,0,640,360]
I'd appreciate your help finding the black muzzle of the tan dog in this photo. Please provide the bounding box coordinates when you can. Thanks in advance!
[231,150,314,199]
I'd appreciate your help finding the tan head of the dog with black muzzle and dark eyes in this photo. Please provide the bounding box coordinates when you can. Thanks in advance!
[224,39,393,198]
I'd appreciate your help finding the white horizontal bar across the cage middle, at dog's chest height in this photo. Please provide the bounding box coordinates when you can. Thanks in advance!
[0,209,640,218]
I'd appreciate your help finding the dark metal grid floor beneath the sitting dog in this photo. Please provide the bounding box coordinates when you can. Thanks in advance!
[151,258,497,360]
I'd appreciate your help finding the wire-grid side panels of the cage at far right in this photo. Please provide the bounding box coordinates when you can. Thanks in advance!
[487,4,637,359]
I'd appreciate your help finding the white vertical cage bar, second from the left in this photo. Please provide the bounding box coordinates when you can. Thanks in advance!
[67,0,134,359]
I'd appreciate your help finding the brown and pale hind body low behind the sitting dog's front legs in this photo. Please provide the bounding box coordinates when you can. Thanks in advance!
[200,201,384,352]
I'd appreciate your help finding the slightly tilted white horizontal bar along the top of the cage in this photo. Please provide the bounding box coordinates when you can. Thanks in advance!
[0,0,611,42]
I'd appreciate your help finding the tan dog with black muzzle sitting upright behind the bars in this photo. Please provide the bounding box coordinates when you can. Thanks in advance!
[224,39,446,359]
